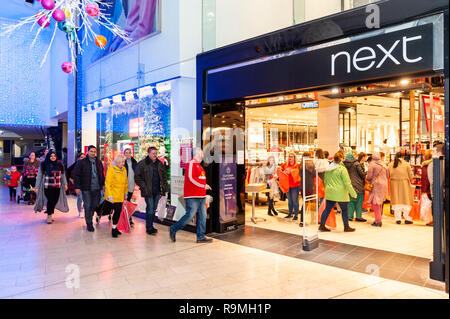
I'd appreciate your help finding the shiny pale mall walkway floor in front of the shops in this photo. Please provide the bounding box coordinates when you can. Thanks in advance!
[0,189,449,299]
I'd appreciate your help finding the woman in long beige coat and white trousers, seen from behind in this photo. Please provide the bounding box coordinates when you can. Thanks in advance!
[388,152,414,224]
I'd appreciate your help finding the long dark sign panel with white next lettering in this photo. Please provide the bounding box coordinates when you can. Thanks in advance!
[206,24,433,102]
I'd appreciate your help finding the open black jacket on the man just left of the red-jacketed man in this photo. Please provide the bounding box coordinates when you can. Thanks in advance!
[134,156,169,197]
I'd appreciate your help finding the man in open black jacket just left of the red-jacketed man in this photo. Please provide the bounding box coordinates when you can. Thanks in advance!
[134,146,169,235]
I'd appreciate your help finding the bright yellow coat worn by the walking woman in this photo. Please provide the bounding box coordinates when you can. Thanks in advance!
[105,165,128,203]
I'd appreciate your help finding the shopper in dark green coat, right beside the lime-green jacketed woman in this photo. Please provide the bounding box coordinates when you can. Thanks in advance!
[343,152,367,222]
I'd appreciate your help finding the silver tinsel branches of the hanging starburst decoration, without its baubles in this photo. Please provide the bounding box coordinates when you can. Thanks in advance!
[0,0,131,67]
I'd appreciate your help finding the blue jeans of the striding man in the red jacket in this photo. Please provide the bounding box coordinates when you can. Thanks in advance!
[170,198,206,240]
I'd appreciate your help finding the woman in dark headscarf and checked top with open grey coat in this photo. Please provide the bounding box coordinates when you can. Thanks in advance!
[34,150,69,224]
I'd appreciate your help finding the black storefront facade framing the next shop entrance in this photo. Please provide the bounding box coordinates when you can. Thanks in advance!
[197,0,449,291]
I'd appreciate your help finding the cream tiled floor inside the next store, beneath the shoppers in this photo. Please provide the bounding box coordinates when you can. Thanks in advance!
[246,201,433,259]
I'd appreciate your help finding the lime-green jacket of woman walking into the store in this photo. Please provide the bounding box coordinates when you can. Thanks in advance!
[324,163,357,202]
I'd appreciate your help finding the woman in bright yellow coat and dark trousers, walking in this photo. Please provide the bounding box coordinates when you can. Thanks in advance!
[105,154,128,238]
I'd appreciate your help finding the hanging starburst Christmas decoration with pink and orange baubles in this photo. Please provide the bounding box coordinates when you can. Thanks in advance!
[0,0,131,69]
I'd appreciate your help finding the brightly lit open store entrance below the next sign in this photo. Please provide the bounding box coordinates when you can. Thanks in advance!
[244,76,444,259]
